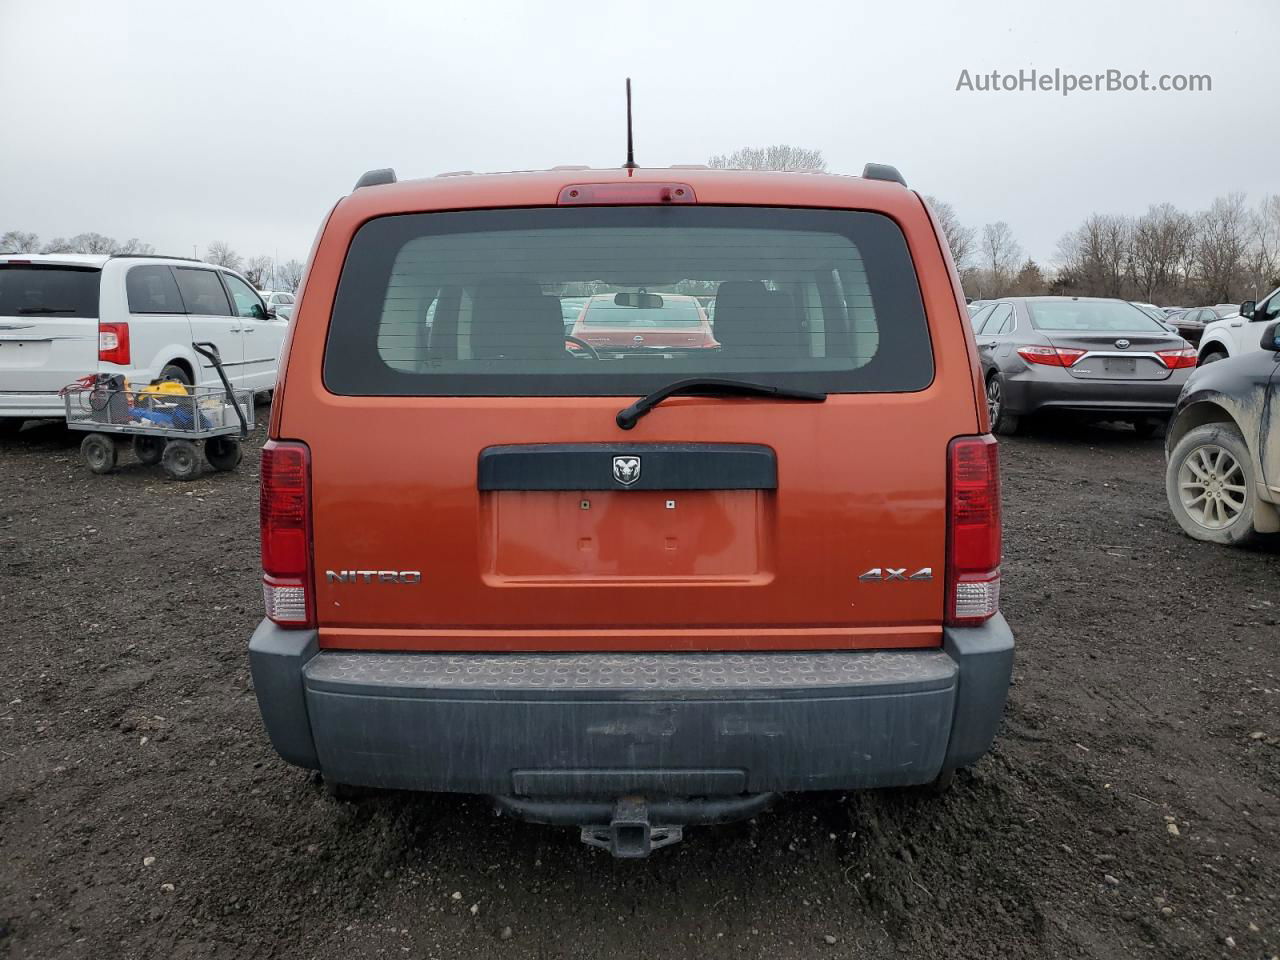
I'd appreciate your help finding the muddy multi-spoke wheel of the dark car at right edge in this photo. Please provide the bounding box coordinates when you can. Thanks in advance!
[1165,424,1257,544]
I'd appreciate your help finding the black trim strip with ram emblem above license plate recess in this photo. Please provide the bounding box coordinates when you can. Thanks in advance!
[476,443,778,490]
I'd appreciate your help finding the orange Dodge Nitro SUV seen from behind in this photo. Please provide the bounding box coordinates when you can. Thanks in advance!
[250,164,1012,856]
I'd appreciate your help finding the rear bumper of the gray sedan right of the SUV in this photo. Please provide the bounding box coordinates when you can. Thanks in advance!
[1005,367,1190,416]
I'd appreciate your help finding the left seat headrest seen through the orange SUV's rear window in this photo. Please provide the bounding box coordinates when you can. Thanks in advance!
[471,280,564,360]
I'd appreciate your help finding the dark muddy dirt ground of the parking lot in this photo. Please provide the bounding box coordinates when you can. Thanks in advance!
[0,408,1280,960]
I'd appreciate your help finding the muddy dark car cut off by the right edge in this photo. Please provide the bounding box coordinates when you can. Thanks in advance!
[1165,323,1280,544]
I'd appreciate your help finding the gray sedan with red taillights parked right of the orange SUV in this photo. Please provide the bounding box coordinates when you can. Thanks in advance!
[972,297,1196,436]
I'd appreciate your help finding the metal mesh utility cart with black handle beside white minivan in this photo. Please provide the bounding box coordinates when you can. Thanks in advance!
[61,343,253,480]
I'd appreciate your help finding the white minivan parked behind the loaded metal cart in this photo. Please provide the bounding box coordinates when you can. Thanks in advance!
[0,253,289,433]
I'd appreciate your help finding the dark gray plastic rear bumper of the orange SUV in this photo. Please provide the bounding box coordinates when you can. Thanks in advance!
[250,617,1014,799]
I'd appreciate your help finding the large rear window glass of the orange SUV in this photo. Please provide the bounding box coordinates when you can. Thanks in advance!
[324,206,933,396]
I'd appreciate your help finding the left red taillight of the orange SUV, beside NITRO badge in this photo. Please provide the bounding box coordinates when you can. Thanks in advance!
[259,440,315,627]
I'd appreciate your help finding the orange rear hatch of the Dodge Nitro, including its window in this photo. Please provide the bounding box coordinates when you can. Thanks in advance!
[272,179,977,650]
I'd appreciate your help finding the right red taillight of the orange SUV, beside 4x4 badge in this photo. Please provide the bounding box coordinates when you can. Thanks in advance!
[946,434,1000,627]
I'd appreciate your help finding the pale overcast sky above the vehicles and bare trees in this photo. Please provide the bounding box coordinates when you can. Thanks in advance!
[0,0,1280,267]
